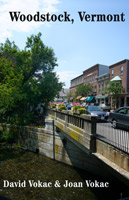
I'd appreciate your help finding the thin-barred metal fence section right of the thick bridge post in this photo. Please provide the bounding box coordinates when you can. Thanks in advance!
[96,121,129,153]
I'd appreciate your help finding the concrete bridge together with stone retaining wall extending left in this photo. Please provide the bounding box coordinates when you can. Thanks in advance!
[0,109,129,186]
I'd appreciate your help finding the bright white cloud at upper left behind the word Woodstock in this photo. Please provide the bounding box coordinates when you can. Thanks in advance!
[0,0,60,42]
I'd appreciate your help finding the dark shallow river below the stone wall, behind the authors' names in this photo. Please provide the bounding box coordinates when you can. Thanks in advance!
[0,147,129,200]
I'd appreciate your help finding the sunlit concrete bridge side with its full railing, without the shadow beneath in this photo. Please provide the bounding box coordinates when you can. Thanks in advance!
[49,110,129,171]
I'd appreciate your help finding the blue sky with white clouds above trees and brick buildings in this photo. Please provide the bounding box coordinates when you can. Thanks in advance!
[0,0,129,88]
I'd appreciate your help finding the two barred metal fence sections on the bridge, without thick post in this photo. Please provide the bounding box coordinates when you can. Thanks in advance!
[49,110,129,153]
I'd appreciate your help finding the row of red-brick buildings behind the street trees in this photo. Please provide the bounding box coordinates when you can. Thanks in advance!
[70,59,129,108]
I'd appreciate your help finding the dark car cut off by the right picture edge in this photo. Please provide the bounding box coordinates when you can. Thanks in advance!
[109,106,129,128]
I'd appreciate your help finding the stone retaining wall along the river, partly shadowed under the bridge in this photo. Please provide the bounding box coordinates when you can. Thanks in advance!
[0,118,100,172]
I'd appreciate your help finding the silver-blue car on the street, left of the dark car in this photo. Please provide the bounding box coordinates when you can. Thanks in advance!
[86,106,108,120]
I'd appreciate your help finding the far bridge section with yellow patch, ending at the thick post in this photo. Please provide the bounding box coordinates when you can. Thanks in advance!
[48,109,96,152]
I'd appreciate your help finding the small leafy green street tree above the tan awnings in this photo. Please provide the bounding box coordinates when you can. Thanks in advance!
[75,83,92,97]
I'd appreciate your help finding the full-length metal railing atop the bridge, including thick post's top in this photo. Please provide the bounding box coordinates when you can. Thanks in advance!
[49,110,129,153]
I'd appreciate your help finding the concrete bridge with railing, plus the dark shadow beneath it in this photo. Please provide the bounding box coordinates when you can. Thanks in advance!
[49,110,129,185]
